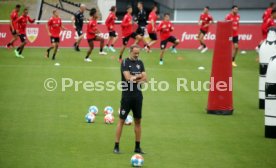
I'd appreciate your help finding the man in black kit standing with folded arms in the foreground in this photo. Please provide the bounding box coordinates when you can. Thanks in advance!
[113,45,147,154]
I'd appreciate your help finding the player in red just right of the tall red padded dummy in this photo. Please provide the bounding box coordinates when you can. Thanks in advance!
[225,5,240,67]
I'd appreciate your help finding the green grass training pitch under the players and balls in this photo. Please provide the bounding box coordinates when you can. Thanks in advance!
[0,48,276,168]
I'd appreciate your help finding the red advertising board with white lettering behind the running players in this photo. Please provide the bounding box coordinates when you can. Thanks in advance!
[0,24,262,50]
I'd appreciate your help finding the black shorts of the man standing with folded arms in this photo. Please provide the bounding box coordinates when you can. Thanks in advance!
[120,96,143,120]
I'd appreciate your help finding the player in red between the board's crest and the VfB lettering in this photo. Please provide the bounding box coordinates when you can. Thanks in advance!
[46,10,65,60]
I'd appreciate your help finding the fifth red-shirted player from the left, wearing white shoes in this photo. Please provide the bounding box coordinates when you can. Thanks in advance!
[105,6,118,52]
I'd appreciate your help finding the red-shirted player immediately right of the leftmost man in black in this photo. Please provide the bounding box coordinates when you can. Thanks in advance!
[84,8,106,62]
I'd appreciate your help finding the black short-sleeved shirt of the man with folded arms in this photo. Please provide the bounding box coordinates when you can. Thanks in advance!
[121,58,145,96]
